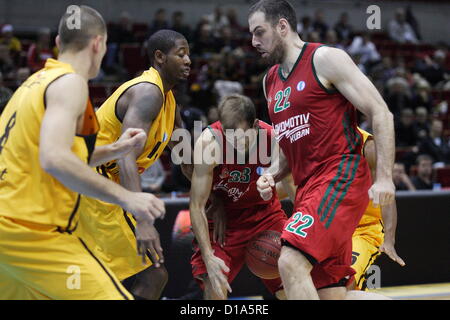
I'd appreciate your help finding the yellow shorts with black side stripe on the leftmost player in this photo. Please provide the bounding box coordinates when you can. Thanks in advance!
[0,216,133,300]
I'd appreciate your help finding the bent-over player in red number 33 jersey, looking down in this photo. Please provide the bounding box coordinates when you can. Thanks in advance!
[189,95,287,300]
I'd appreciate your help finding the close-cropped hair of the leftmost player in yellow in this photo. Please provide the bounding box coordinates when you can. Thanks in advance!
[58,6,107,52]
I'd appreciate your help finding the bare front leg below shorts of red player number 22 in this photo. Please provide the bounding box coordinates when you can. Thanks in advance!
[278,245,319,300]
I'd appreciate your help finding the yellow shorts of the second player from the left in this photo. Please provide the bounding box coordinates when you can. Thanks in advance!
[76,197,153,281]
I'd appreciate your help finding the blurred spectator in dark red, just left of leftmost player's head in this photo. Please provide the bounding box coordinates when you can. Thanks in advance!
[27,28,57,73]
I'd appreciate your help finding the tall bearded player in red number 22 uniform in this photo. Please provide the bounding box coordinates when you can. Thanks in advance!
[249,0,395,299]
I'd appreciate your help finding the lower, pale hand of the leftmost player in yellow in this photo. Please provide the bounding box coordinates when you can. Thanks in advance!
[121,192,166,224]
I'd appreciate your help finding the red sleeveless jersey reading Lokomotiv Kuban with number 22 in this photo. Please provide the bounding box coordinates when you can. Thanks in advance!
[265,42,369,187]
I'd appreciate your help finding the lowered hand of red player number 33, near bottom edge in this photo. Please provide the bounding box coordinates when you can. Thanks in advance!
[205,254,231,299]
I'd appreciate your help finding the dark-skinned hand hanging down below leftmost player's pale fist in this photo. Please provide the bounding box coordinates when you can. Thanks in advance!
[136,221,164,268]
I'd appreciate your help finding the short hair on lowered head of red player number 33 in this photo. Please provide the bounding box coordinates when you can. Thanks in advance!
[219,94,256,129]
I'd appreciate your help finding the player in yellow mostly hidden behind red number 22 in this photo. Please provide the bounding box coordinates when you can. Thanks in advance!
[348,128,405,290]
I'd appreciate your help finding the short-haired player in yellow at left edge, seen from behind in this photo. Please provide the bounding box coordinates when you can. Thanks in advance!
[0,6,164,300]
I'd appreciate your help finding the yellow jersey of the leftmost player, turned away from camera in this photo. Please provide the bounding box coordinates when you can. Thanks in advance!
[0,59,99,232]
